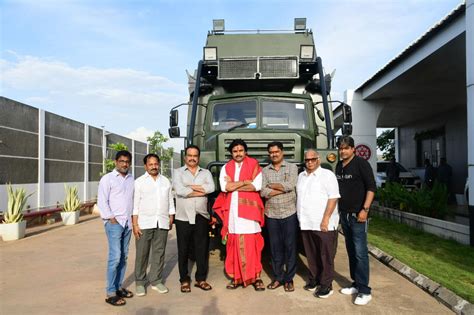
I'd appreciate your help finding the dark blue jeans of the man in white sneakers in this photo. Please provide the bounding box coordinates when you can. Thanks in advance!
[340,212,371,294]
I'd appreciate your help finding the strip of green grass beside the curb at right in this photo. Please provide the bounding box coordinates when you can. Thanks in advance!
[369,216,474,303]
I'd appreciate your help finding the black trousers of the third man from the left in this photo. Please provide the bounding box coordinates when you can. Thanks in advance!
[175,214,209,283]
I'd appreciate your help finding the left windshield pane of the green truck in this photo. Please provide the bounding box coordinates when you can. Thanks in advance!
[212,100,257,130]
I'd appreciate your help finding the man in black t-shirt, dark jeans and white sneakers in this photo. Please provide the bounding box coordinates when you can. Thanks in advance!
[336,136,376,305]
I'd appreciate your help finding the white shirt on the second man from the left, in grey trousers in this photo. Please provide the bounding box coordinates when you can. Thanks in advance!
[133,173,175,230]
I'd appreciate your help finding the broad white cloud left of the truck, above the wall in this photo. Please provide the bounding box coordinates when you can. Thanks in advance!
[0,56,188,138]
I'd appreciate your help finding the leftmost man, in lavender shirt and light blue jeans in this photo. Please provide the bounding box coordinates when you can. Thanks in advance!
[97,150,134,306]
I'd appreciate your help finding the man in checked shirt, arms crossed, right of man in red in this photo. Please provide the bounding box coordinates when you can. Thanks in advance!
[260,141,298,292]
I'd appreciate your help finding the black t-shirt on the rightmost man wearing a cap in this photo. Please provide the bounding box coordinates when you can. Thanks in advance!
[336,156,376,212]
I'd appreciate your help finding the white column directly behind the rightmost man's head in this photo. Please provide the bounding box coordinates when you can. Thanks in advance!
[350,92,384,172]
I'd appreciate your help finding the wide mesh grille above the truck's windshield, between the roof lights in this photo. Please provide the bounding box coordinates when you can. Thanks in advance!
[218,56,298,80]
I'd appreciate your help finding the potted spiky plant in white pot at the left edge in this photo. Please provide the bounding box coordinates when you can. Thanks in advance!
[2,184,33,241]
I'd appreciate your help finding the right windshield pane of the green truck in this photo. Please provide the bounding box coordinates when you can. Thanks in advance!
[262,100,308,129]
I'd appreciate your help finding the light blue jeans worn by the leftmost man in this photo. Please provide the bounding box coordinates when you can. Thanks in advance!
[105,221,132,296]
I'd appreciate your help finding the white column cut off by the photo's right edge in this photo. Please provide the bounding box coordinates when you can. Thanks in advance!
[466,0,474,246]
